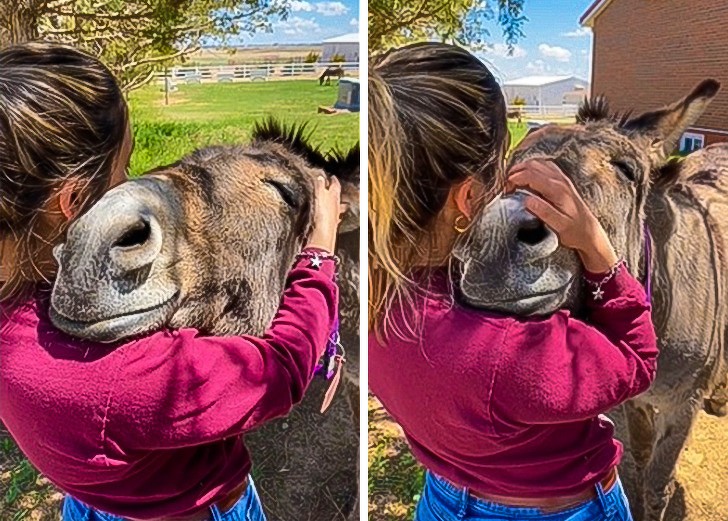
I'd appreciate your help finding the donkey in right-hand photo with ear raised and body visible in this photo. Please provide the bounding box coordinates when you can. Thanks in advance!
[457,80,728,521]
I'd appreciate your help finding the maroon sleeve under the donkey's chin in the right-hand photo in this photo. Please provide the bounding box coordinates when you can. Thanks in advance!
[491,266,658,424]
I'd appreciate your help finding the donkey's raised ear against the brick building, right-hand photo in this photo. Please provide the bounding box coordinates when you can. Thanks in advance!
[621,80,720,167]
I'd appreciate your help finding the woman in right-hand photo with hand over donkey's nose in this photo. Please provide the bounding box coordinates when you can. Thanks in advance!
[369,43,657,521]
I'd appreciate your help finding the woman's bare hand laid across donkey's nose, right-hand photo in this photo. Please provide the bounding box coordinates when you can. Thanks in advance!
[506,160,618,273]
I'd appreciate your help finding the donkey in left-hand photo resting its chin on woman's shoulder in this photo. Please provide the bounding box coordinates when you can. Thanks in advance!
[51,120,359,521]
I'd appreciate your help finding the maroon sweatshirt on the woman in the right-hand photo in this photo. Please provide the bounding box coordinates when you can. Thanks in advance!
[369,268,657,498]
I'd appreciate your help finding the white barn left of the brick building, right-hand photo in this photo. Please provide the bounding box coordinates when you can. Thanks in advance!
[503,76,589,106]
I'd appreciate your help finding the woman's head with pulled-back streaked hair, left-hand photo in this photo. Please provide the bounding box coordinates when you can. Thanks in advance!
[0,43,132,301]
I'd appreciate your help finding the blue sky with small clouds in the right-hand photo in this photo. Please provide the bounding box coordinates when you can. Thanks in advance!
[482,0,592,80]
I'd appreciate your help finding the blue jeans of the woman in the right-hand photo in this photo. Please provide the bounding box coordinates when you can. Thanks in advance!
[415,472,632,521]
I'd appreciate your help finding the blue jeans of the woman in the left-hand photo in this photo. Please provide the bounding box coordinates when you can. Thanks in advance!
[62,478,266,521]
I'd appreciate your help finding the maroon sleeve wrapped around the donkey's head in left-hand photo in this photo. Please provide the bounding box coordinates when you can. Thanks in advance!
[104,254,338,450]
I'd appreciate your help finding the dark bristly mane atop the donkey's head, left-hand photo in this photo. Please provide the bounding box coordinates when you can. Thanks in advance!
[252,117,359,181]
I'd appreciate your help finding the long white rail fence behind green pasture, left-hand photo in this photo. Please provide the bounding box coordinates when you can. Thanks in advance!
[156,62,359,85]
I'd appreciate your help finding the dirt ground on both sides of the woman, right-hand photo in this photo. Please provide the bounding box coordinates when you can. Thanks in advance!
[369,398,728,521]
